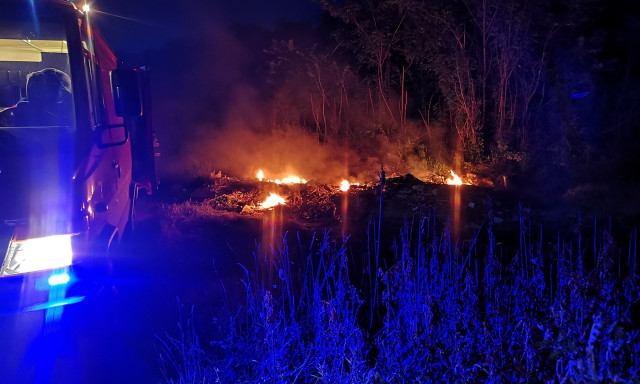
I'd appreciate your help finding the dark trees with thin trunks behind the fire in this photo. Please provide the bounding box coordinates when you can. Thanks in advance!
[271,0,640,178]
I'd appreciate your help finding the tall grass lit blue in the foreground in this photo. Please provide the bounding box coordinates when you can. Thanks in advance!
[162,213,640,383]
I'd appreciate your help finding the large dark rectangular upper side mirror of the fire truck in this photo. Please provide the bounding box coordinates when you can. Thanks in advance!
[111,69,142,117]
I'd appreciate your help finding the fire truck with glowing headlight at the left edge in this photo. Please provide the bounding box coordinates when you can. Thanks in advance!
[0,0,156,296]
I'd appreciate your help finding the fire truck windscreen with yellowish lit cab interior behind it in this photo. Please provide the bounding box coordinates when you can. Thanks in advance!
[0,16,75,129]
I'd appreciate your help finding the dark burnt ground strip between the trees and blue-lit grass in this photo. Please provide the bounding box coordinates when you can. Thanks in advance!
[159,175,640,256]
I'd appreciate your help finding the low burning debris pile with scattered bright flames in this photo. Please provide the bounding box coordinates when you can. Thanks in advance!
[164,169,490,225]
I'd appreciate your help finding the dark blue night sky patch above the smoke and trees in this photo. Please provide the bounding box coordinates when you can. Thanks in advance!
[94,0,321,55]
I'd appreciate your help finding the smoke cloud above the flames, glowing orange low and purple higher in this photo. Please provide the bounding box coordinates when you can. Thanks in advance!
[151,22,450,183]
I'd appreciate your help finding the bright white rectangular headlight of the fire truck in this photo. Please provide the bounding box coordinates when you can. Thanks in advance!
[0,234,73,276]
